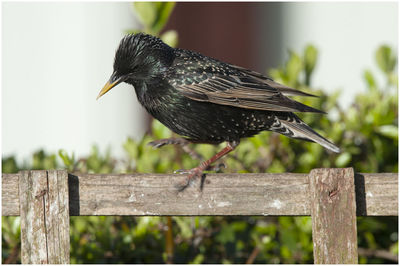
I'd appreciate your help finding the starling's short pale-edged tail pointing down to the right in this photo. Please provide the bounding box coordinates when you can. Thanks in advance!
[274,114,340,153]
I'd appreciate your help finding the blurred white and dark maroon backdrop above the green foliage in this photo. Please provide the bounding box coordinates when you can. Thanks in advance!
[2,2,398,160]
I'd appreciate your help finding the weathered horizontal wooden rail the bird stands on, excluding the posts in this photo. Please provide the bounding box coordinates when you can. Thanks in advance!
[2,170,398,216]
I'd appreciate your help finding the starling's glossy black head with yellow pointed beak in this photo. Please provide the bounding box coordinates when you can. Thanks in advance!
[97,33,174,99]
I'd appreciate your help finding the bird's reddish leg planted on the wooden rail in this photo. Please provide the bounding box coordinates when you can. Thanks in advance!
[176,141,239,191]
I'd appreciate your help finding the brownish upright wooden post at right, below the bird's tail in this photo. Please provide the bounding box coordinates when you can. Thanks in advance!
[309,168,358,264]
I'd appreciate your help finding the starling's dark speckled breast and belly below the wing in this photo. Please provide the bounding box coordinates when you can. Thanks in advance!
[135,80,273,143]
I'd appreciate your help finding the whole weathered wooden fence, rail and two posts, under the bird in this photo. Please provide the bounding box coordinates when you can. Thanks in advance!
[2,168,398,264]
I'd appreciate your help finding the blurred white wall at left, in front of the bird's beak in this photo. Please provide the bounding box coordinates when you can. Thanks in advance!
[2,2,144,162]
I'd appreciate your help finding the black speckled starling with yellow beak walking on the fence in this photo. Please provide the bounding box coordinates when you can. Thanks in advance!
[97,33,340,190]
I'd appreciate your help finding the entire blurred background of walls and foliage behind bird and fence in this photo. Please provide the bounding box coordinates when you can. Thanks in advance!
[1,1,399,264]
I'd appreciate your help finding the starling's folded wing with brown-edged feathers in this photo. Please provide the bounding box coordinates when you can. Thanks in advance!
[173,60,323,113]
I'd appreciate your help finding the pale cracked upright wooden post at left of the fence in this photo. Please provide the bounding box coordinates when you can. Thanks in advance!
[19,170,70,264]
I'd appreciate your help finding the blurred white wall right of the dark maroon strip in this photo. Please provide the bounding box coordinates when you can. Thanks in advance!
[281,1,398,106]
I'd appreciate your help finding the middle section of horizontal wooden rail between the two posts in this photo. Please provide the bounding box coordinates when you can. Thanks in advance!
[70,174,309,215]
